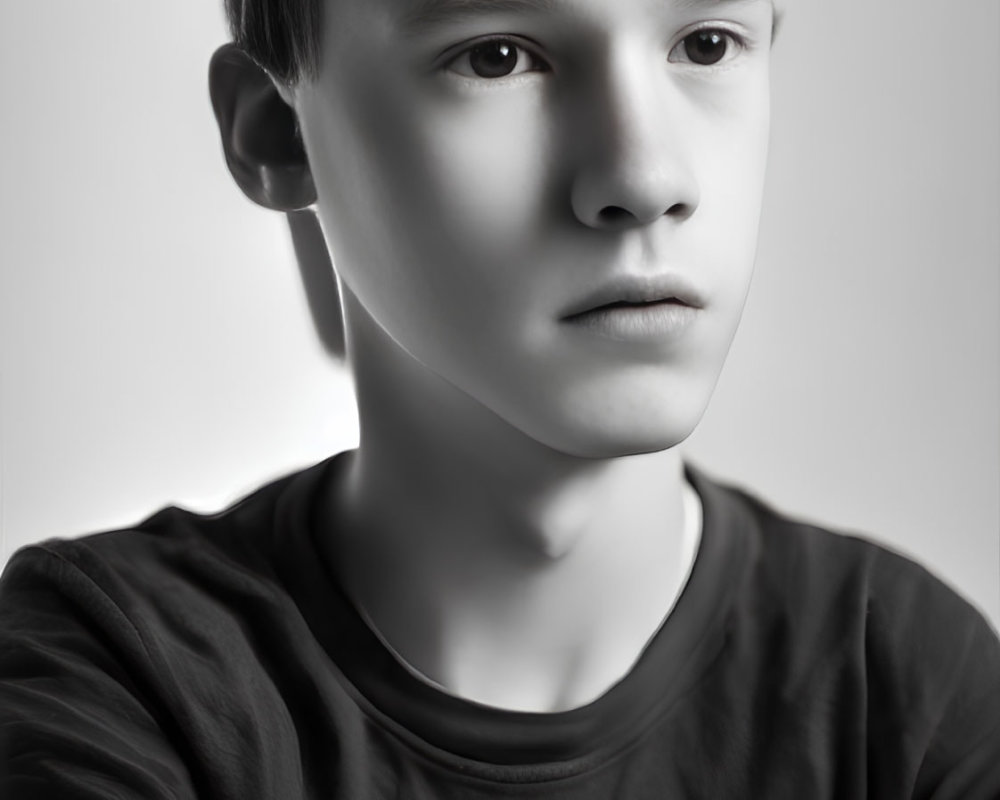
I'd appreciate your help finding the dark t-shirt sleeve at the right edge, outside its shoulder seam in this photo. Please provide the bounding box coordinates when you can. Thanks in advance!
[868,556,1000,800]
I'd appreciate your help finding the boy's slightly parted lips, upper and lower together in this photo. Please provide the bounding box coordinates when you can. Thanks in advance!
[561,274,705,341]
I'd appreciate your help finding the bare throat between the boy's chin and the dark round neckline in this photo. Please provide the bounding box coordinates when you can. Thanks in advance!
[337,453,701,712]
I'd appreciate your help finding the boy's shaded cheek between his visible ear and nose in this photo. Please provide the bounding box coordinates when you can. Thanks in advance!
[304,79,560,376]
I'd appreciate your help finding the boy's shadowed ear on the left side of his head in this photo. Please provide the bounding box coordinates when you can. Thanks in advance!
[208,44,316,211]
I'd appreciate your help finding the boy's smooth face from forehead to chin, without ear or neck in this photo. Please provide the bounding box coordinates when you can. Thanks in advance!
[294,0,773,457]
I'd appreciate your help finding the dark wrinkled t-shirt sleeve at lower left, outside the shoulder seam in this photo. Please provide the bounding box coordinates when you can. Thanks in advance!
[0,545,196,800]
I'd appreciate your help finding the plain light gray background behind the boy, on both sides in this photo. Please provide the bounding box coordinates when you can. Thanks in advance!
[0,0,1000,625]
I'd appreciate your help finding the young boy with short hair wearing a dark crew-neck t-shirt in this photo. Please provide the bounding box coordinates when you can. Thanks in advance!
[0,0,1000,800]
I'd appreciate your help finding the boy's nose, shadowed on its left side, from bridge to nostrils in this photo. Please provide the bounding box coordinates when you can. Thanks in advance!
[570,49,699,230]
